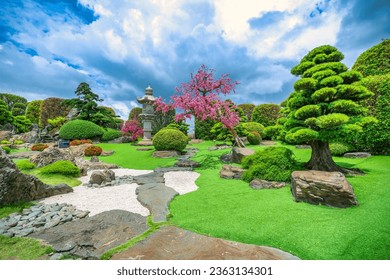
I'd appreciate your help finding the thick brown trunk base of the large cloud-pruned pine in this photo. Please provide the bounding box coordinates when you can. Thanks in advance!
[306,140,362,175]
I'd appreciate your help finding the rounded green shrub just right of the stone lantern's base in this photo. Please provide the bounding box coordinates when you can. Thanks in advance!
[153,128,188,151]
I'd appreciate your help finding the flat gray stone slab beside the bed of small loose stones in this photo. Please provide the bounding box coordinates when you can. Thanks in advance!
[29,210,148,259]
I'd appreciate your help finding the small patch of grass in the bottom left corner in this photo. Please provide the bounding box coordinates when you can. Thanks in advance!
[0,235,53,260]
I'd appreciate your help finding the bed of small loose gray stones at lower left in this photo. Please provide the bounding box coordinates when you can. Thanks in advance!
[0,203,89,237]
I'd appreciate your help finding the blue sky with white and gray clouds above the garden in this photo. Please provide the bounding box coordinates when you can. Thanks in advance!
[0,0,390,117]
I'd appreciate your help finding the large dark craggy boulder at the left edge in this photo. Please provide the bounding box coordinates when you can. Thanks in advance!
[0,150,73,206]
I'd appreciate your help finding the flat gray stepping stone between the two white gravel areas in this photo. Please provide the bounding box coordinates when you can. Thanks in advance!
[136,183,179,223]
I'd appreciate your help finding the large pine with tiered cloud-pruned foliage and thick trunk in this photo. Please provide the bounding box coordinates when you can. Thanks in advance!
[284,46,375,173]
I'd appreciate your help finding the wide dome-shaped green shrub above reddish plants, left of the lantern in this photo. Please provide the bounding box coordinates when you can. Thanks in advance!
[60,120,104,140]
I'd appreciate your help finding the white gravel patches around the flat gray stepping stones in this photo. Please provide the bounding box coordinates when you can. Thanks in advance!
[40,168,199,216]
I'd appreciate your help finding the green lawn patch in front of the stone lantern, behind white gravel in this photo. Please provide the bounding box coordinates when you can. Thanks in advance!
[97,143,176,170]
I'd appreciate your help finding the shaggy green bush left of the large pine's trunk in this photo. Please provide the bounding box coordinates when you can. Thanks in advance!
[241,147,297,182]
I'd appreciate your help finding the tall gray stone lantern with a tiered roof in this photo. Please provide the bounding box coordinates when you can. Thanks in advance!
[137,85,156,146]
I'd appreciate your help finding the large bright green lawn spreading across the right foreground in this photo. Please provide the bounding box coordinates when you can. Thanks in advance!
[170,142,390,260]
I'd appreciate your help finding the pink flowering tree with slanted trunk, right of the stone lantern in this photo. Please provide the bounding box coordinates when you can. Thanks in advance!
[155,65,245,147]
